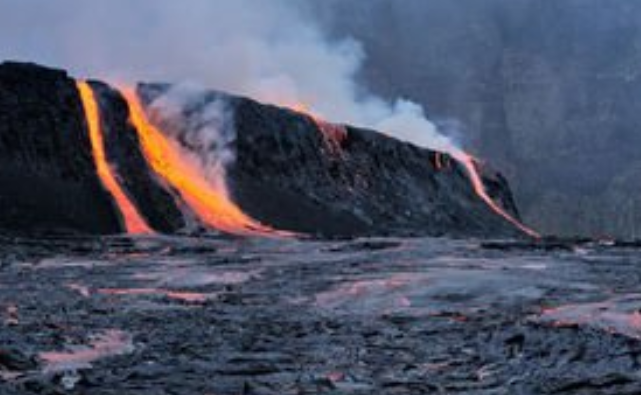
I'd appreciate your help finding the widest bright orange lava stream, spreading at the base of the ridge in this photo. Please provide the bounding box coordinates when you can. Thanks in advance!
[121,89,295,237]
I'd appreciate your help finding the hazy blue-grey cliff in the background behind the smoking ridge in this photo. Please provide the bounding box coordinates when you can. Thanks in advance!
[320,0,641,237]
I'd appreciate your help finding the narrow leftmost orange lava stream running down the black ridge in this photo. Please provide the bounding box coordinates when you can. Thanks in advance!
[76,81,154,234]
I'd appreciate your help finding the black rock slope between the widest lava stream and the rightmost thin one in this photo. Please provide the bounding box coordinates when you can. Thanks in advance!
[232,101,512,236]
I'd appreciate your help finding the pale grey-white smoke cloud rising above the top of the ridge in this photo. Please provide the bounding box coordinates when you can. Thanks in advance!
[0,0,458,153]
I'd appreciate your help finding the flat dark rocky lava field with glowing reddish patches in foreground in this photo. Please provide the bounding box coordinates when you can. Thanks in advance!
[0,237,641,395]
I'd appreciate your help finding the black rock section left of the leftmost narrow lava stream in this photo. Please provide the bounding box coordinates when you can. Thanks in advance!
[0,63,120,233]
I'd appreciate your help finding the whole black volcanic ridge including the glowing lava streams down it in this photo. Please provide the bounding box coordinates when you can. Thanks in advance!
[0,62,536,237]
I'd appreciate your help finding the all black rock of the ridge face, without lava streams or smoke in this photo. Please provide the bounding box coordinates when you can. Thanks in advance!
[0,64,519,237]
